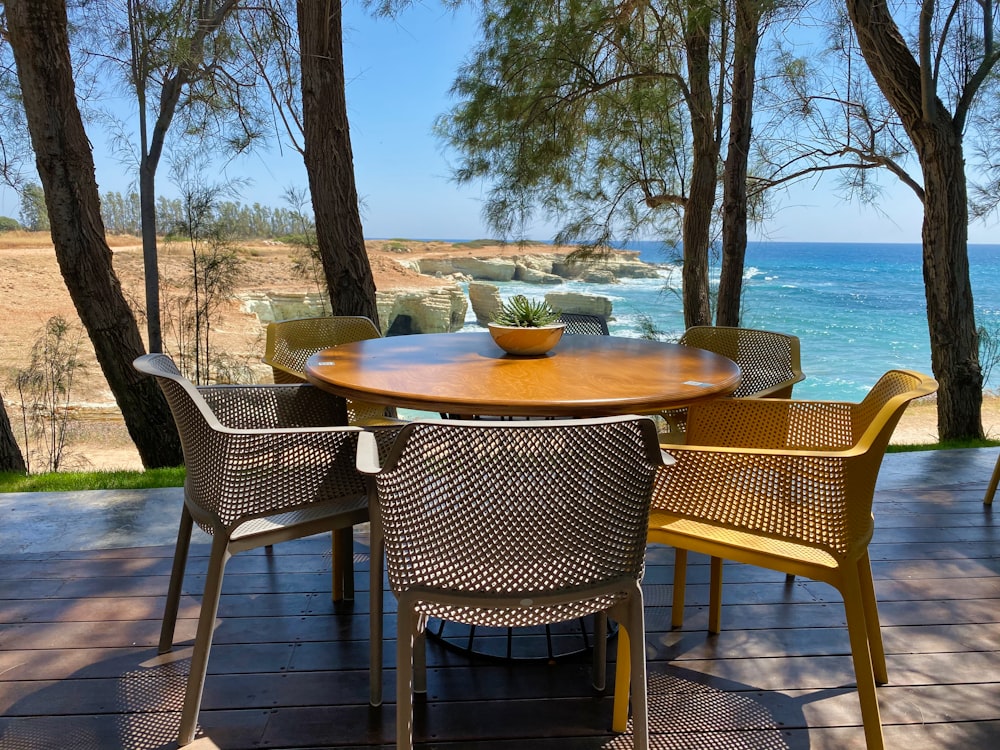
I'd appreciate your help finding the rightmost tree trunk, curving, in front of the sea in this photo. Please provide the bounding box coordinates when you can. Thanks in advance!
[847,0,983,440]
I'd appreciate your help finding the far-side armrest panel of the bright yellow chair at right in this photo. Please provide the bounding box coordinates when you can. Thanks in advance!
[686,398,860,451]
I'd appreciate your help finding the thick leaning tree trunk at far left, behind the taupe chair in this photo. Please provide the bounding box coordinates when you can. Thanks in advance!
[5,0,183,467]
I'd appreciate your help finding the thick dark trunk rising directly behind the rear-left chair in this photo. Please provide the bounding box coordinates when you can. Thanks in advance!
[296,0,379,325]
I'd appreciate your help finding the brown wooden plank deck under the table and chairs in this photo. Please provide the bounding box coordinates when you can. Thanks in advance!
[0,450,1000,750]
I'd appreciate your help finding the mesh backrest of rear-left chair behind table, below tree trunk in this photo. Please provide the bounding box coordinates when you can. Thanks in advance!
[264,315,382,383]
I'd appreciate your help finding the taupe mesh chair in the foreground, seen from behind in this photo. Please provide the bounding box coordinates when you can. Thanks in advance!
[358,416,663,750]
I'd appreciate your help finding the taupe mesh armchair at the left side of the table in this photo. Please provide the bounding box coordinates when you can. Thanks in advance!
[135,354,374,745]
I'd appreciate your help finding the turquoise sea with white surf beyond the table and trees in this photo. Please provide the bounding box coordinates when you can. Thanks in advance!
[458,242,1000,401]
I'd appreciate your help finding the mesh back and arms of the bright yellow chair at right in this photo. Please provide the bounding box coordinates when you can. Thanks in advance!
[680,370,937,554]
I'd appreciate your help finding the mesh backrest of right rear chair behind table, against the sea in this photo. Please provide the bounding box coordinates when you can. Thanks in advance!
[679,326,805,398]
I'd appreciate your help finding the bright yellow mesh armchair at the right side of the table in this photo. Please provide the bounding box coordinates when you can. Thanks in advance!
[649,370,937,750]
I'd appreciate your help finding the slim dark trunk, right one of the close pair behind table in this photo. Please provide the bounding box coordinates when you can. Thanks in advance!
[715,0,760,326]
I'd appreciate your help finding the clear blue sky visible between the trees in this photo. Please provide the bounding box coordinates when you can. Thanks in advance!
[0,0,1000,242]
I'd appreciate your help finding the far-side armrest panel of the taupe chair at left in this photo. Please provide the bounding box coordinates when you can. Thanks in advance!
[198,384,347,430]
